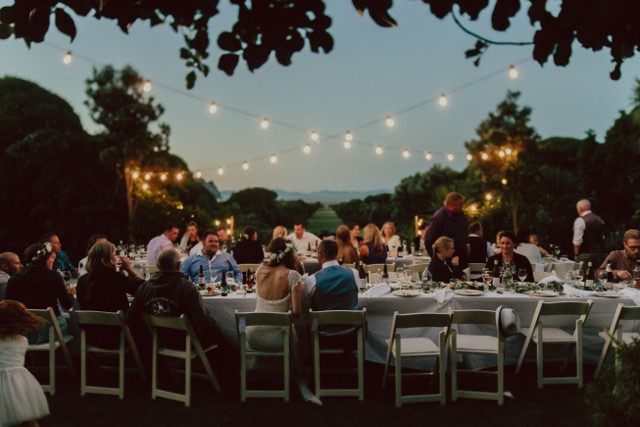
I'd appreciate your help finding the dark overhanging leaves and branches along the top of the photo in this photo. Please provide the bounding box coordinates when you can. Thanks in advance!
[0,0,640,88]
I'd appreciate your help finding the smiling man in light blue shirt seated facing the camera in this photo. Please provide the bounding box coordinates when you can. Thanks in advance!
[180,230,242,283]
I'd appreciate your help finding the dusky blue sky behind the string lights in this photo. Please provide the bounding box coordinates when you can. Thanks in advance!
[0,0,640,192]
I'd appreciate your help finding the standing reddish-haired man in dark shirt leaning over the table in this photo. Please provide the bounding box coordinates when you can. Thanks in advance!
[424,193,469,270]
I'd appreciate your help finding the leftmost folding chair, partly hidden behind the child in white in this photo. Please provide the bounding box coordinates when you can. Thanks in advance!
[27,307,76,396]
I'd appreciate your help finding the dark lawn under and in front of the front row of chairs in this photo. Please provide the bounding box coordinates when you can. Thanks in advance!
[41,362,593,427]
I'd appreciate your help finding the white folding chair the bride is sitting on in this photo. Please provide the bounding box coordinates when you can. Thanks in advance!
[235,310,292,402]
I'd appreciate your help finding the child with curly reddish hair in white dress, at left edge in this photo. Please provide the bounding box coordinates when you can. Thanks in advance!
[0,300,49,427]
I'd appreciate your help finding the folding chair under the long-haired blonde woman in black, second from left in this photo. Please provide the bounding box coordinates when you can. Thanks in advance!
[73,310,146,399]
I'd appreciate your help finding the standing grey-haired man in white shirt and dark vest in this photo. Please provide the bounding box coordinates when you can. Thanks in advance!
[573,199,604,266]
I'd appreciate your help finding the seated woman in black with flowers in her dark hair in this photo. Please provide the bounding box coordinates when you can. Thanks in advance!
[5,242,73,344]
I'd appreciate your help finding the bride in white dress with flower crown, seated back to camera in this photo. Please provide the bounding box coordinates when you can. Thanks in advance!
[247,237,322,405]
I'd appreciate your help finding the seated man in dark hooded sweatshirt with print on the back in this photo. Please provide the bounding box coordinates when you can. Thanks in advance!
[126,249,218,347]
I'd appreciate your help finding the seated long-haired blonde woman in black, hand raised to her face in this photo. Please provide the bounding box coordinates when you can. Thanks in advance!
[76,241,144,348]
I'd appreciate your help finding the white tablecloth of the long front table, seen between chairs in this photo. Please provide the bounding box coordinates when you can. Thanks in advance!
[204,292,636,369]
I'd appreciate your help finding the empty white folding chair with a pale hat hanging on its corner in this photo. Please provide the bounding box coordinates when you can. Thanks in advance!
[449,307,506,406]
